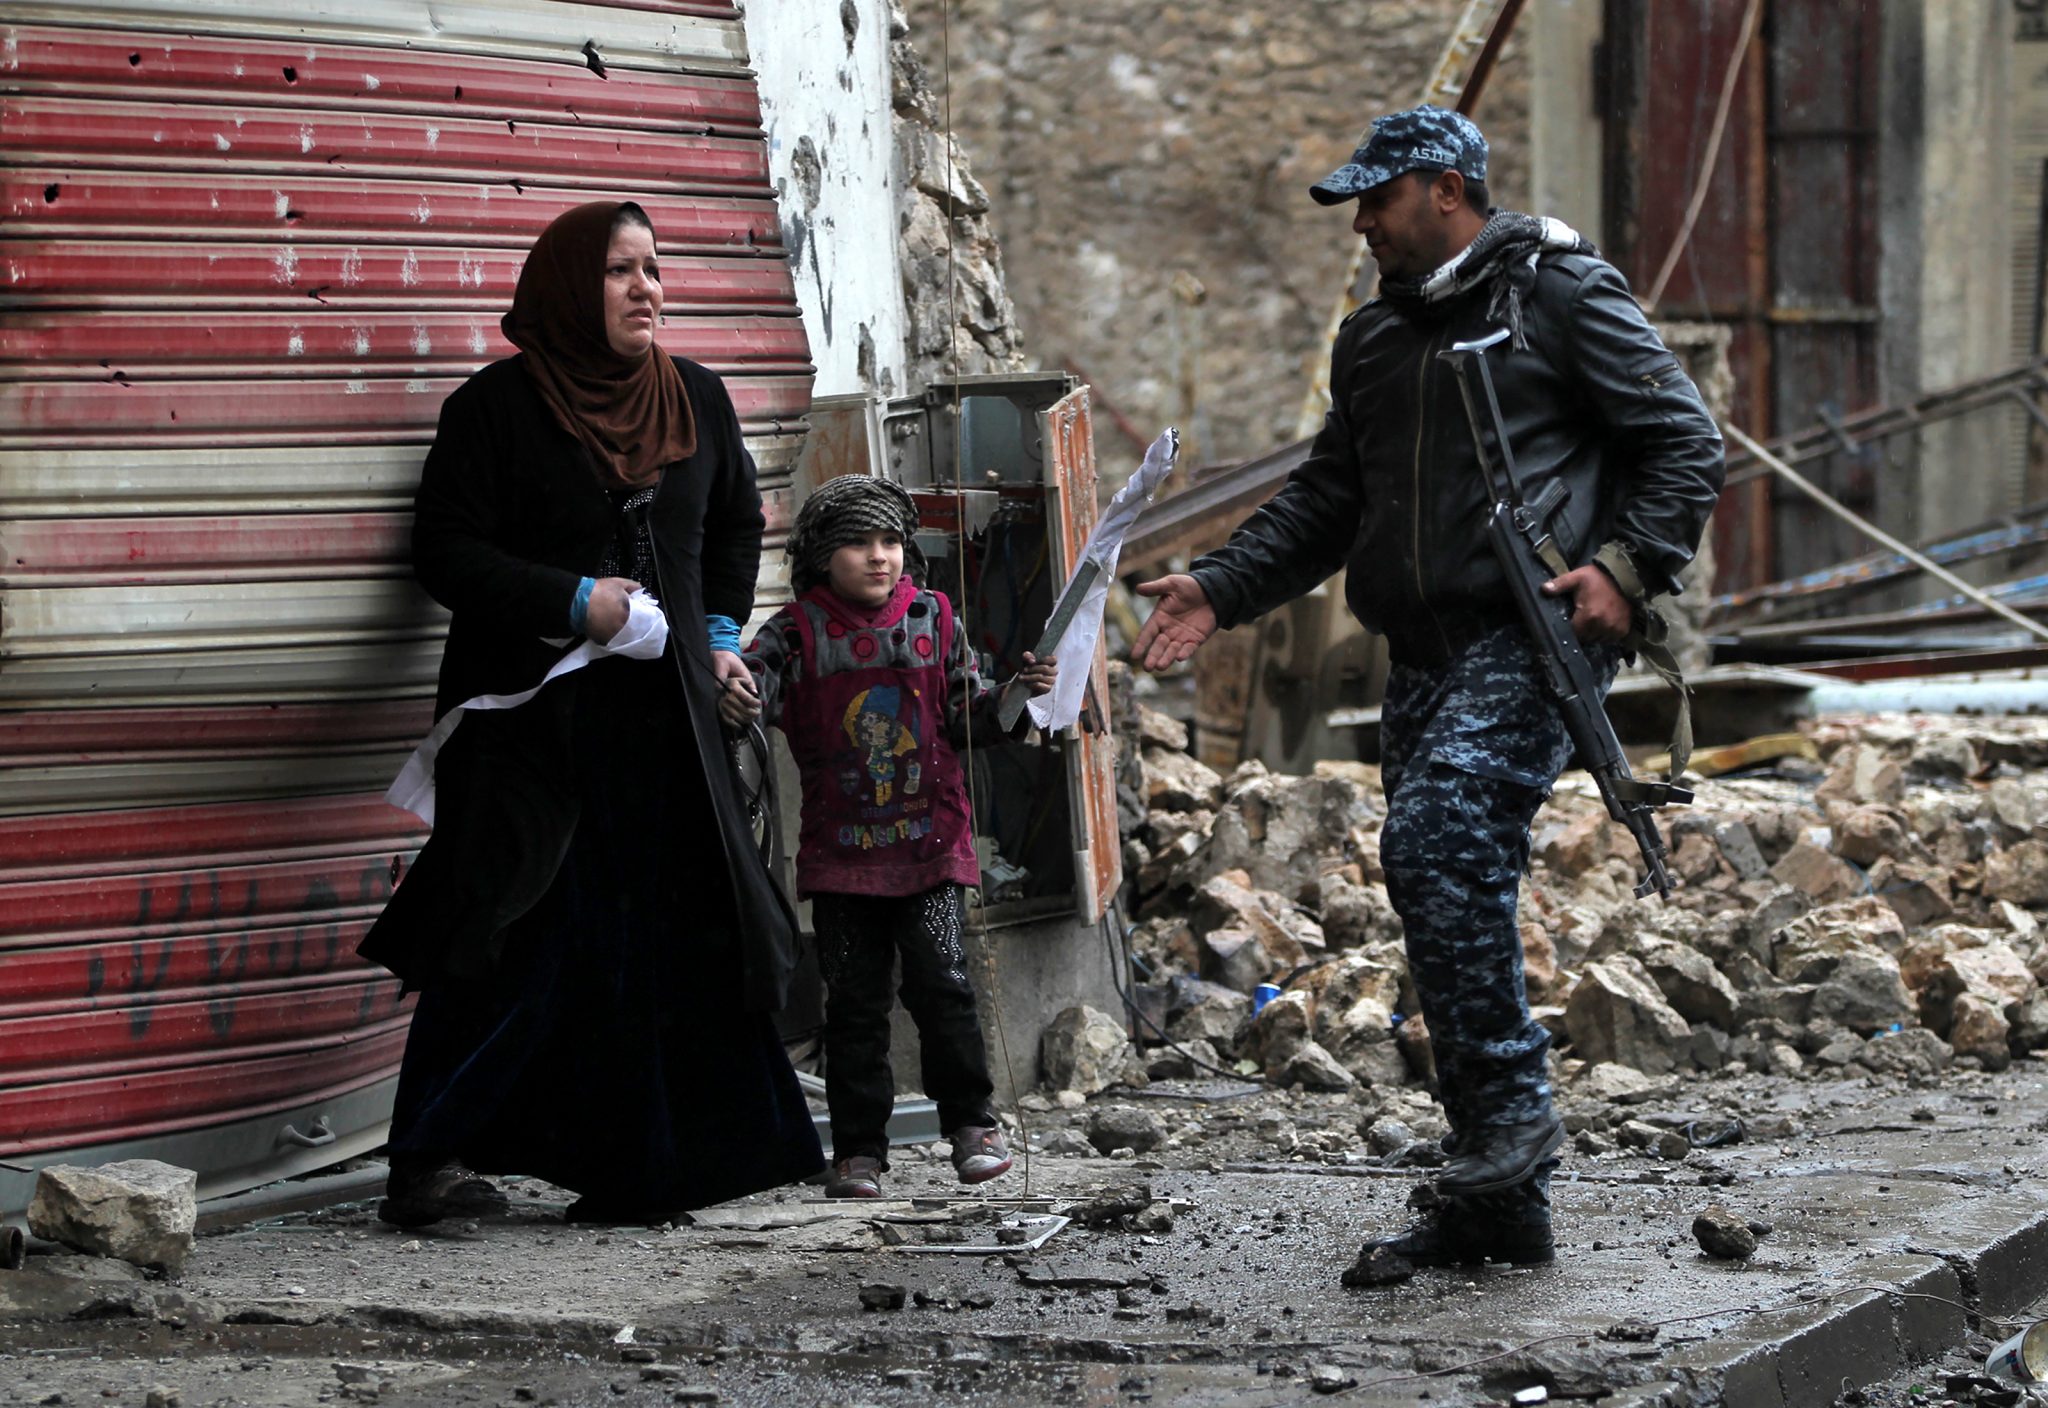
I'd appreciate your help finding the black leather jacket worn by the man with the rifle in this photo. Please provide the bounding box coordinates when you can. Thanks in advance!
[1190,254,1722,665]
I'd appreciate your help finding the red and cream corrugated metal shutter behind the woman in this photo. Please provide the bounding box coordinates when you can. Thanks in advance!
[0,0,811,1187]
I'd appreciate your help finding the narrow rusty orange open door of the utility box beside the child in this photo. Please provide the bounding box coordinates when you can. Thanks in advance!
[1038,387,1124,923]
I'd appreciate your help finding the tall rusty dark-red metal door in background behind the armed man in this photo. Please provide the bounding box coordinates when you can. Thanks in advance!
[1602,0,1880,589]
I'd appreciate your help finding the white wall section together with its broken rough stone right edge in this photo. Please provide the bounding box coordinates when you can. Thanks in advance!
[748,0,1024,395]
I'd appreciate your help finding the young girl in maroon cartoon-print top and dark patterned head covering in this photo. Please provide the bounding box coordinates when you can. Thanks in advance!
[721,475,1057,1197]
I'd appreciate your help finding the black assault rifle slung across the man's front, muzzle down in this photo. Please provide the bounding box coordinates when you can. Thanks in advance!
[1438,327,1692,896]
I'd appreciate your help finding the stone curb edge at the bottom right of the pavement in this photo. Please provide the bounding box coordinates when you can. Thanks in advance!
[1602,1203,2048,1408]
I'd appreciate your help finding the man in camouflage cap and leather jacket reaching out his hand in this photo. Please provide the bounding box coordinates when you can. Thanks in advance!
[1133,106,1722,1267]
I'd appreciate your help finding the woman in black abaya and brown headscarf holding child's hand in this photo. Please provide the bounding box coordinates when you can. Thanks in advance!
[362,203,823,1226]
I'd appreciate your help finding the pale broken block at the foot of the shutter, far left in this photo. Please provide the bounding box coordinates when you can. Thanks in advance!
[29,1158,199,1271]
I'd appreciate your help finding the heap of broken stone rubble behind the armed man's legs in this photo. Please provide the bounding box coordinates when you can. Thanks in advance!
[1089,706,2048,1129]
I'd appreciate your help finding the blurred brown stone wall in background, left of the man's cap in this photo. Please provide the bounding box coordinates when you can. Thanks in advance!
[909,0,1530,475]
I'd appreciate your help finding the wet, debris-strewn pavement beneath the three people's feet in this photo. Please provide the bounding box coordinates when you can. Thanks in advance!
[0,1060,2048,1408]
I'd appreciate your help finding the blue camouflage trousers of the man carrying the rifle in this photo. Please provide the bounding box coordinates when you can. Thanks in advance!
[1380,624,1618,1218]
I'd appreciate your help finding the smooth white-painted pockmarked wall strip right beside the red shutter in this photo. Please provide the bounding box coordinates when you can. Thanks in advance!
[745,0,907,395]
